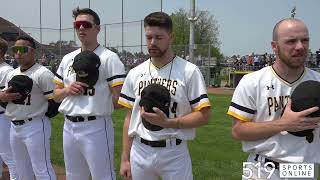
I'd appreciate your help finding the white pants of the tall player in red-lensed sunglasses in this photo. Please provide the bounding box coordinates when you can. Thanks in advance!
[63,117,116,180]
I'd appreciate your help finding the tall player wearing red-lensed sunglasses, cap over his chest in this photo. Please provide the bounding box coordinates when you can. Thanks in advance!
[54,8,125,180]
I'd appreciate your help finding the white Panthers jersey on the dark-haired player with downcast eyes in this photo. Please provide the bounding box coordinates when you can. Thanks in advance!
[118,56,210,141]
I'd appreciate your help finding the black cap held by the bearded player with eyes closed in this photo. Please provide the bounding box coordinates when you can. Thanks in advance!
[139,84,171,131]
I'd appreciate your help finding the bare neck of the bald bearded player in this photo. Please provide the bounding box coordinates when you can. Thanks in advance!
[272,59,304,82]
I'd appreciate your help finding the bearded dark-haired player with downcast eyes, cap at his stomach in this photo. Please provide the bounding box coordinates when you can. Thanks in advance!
[119,12,210,180]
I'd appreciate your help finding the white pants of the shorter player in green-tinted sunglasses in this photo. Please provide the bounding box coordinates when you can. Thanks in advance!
[10,117,56,180]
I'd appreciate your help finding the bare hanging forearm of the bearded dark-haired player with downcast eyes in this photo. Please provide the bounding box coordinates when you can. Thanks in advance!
[121,111,133,160]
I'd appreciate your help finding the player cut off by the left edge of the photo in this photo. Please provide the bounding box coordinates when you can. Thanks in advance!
[0,39,17,179]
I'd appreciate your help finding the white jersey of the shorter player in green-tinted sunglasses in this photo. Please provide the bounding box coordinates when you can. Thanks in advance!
[6,63,55,121]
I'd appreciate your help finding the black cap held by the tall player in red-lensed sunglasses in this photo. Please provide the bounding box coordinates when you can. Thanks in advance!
[72,51,101,87]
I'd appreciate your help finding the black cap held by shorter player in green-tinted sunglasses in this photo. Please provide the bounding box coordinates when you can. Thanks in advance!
[8,75,33,104]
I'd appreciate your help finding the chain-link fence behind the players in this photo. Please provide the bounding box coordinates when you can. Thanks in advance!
[0,21,219,85]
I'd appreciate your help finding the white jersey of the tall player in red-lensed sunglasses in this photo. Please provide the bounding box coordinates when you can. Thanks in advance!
[54,45,126,116]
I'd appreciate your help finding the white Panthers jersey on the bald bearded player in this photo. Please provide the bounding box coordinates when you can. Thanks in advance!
[227,66,320,163]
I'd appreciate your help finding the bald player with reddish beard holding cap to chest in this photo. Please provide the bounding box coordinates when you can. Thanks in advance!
[227,18,320,180]
